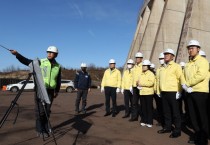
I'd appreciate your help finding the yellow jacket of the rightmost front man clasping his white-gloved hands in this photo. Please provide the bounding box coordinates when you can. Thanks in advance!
[183,55,209,93]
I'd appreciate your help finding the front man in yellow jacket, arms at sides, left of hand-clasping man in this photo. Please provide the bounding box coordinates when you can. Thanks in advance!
[158,49,182,138]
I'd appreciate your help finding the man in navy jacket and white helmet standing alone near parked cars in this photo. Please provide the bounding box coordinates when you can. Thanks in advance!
[74,63,91,115]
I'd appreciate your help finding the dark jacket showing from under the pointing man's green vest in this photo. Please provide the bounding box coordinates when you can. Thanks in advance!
[16,53,61,92]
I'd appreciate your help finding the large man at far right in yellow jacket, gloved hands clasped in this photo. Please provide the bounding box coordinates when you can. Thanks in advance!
[182,40,209,145]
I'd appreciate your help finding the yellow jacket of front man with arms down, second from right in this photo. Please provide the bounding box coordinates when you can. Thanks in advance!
[159,61,183,92]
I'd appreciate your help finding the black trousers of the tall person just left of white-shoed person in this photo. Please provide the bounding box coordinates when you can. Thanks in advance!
[131,87,141,118]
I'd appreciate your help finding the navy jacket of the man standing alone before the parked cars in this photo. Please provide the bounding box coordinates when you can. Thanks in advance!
[74,71,91,90]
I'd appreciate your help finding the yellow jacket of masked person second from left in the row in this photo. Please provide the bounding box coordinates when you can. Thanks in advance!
[121,69,133,90]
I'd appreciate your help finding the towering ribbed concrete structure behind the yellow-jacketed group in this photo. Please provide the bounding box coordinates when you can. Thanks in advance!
[127,0,210,65]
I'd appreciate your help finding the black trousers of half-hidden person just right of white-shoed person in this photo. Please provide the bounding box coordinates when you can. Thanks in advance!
[154,94,164,126]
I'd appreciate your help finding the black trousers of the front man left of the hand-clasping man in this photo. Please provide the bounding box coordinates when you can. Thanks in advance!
[161,92,181,132]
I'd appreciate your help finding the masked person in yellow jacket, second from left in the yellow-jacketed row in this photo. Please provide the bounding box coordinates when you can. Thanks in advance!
[121,59,134,118]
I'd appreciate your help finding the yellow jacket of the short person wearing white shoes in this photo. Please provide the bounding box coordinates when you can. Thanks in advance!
[138,70,155,95]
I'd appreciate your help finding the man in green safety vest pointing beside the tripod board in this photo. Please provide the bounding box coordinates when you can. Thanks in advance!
[11,46,61,137]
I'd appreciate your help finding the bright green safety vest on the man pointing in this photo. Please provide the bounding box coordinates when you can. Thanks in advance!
[40,58,60,89]
